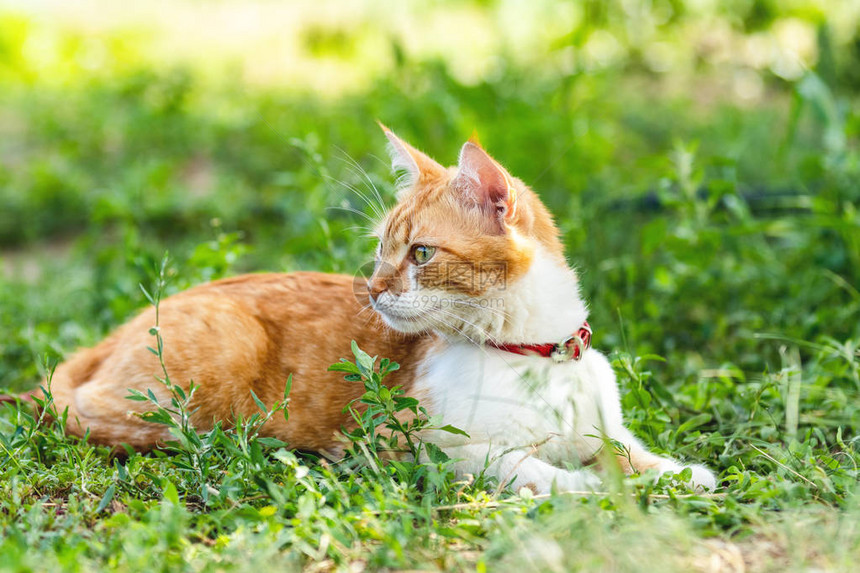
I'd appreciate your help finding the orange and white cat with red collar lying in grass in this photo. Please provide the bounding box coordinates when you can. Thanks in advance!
[23,129,716,492]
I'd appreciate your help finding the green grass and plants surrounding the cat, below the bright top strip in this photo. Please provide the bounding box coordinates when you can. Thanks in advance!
[0,3,860,571]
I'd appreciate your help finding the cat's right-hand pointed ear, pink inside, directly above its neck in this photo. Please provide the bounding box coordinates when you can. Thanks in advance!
[451,137,517,227]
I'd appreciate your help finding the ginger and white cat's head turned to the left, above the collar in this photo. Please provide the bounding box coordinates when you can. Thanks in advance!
[368,127,567,341]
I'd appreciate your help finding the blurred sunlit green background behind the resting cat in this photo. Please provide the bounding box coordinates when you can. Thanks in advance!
[0,0,860,467]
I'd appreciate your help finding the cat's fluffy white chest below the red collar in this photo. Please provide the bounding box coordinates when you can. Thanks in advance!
[418,343,620,462]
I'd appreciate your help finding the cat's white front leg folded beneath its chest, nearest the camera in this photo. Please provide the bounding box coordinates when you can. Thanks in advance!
[445,444,601,494]
